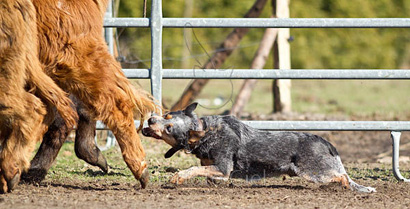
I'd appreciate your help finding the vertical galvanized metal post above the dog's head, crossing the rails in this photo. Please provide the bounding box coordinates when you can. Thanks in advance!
[150,0,163,105]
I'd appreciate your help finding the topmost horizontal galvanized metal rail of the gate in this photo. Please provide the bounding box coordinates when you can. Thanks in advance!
[104,18,410,28]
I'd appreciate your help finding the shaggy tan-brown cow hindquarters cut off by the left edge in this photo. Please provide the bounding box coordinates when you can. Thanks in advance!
[0,0,77,193]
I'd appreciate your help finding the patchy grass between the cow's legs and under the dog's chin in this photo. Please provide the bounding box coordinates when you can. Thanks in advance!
[47,135,199,182]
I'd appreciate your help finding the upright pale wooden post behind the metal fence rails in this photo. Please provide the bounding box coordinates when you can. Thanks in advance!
[272,0,292,112]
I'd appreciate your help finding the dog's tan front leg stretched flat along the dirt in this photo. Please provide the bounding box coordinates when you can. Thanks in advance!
[170,165,225,184]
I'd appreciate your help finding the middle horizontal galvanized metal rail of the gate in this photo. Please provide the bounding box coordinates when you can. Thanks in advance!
[123,69,410,79]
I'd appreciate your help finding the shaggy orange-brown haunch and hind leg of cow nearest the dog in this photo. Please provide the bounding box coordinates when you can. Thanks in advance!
[26,0,157,187]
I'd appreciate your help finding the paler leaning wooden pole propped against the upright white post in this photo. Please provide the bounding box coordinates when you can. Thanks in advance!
[230,24,278,117]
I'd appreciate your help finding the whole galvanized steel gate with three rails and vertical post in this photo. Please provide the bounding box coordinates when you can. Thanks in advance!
[101,0,410,182]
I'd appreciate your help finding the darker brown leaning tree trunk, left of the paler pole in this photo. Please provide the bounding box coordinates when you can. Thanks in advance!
[171,0,267,111]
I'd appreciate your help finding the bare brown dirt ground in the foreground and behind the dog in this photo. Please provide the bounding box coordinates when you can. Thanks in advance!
[0,114,410,208]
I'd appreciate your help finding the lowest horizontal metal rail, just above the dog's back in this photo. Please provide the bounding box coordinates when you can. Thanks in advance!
[97,121,410,131]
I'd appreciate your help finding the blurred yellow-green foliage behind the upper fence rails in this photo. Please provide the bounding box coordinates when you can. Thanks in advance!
[116,0,410,69]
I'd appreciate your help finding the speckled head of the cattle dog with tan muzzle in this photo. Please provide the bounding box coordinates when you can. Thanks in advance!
[142,103,205,158]
